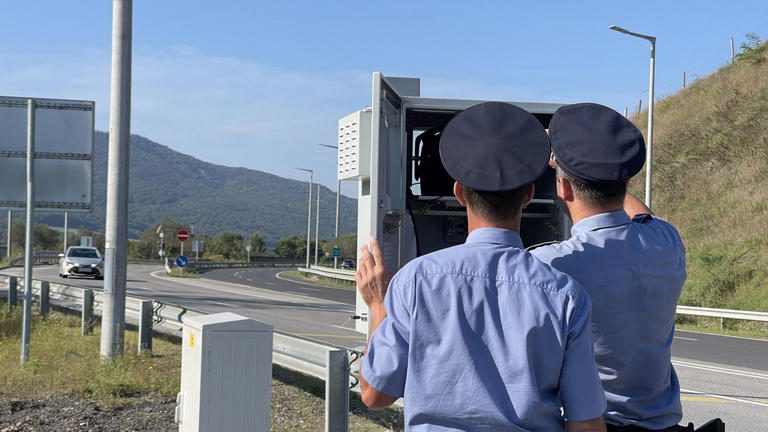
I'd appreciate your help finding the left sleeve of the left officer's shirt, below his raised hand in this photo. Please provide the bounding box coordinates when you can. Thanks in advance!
[361,277,411,397]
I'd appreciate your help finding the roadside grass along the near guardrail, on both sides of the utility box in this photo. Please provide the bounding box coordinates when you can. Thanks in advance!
[0,301,402,432]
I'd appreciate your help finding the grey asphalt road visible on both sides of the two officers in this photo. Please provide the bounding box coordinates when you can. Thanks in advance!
[3,266,768,432]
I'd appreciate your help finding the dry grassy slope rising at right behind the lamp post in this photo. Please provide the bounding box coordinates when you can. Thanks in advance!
[633,40,768,311]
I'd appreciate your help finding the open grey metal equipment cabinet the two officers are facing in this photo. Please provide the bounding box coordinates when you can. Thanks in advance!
[352,72,570,333]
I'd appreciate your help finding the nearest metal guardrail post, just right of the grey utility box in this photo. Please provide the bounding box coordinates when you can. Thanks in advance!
[325,349,349,432]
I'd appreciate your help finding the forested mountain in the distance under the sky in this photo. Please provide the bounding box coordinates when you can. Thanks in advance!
[38,132,357,246]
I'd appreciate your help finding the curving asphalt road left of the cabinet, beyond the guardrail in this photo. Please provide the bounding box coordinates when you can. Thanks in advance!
[3,265,365,349]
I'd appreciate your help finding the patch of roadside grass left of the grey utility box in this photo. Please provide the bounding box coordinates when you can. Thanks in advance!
[0,303,181,406]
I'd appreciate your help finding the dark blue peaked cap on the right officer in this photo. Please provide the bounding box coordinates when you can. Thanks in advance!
[549,103,645,182]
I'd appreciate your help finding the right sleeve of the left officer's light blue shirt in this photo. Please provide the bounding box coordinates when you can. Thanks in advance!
[560,286,606,421]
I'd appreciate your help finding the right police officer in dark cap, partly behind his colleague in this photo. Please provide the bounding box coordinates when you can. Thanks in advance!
[532,103,686,432]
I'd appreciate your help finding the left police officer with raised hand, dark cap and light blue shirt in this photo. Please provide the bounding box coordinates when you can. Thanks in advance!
[356,103,606,431]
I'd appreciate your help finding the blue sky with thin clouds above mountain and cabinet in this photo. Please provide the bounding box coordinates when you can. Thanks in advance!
[0,0,768,192]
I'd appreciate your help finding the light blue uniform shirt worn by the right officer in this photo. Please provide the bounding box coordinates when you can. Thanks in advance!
[531,210,686,429]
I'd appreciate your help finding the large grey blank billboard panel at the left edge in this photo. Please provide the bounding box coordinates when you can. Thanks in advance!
[0,96,94,212]
